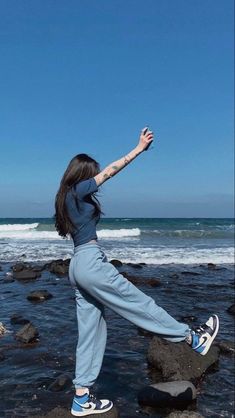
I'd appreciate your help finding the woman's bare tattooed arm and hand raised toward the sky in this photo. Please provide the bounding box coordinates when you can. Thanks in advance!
[94,128,153,186]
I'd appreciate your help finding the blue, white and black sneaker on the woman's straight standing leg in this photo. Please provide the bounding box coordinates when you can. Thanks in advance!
[71,392,113,417]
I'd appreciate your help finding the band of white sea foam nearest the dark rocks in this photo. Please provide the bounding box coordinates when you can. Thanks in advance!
[0,239,234,264]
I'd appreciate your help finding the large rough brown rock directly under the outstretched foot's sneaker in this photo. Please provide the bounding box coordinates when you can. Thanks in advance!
[147,336,219,381]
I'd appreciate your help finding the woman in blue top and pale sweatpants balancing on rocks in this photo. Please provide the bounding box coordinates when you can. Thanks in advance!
[55,128,219,416]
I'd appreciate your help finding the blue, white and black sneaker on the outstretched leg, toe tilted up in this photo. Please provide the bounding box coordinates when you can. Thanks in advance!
[190,315,219,356]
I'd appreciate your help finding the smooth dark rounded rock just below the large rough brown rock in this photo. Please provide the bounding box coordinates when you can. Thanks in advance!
[138,380,197,408]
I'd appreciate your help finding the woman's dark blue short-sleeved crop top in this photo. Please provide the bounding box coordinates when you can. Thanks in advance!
[65,177,100,247]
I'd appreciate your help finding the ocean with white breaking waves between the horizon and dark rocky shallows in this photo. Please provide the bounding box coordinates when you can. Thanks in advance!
[0,218,234,264]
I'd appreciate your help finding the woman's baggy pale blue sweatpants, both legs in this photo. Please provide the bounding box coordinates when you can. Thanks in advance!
[69,242,190,388]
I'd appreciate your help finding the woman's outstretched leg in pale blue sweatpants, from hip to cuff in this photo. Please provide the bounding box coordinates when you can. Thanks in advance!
[73,246,190,342]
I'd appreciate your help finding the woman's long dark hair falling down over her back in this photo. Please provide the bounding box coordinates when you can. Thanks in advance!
[54,154,103,238]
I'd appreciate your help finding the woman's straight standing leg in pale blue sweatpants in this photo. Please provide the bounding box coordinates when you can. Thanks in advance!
[70,273,107,389]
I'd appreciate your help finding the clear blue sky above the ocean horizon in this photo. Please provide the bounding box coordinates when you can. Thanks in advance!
[0,0,233,217]
